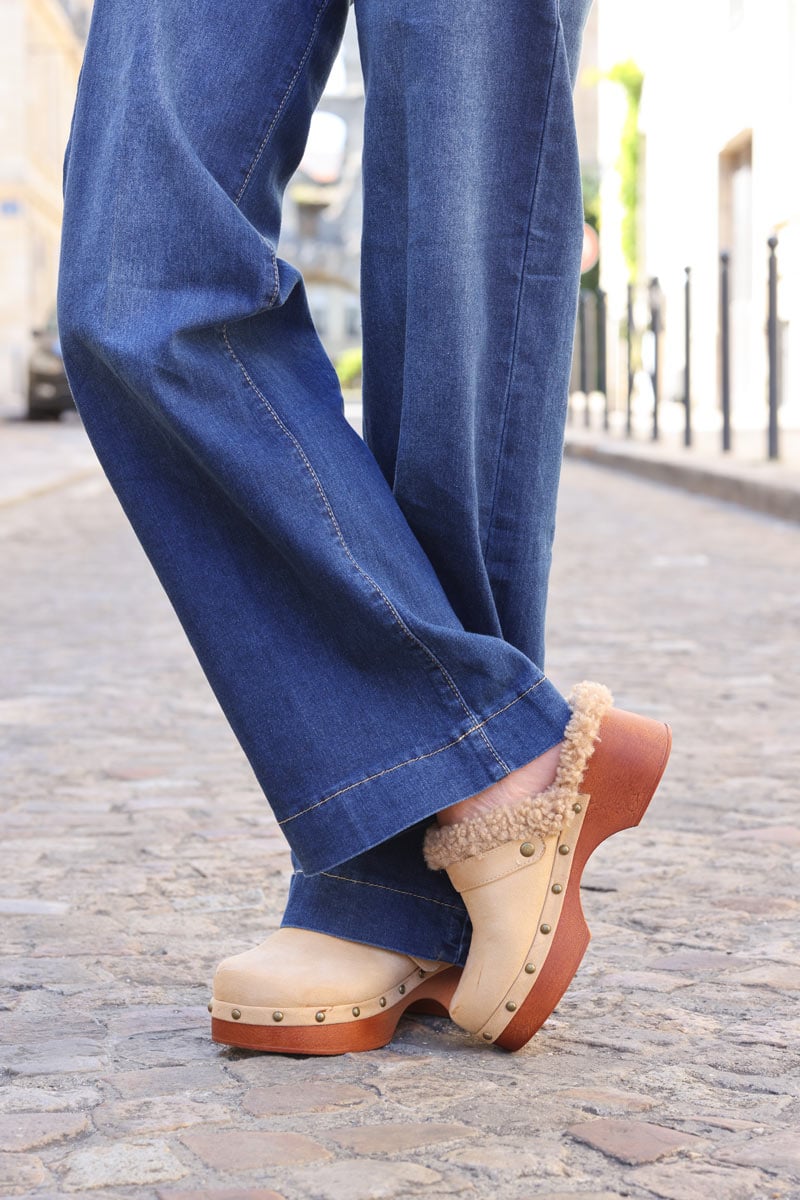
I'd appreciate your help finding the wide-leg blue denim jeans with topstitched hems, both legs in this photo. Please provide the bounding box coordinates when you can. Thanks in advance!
[58,0,588,964]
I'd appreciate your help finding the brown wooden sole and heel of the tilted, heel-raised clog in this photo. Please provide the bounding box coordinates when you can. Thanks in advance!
[495,708,672,1050]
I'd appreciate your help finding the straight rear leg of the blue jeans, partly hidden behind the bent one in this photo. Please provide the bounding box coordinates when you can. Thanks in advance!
[284,0,590,964]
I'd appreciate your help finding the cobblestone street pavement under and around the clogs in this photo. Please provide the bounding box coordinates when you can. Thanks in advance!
[0,434,800,1200]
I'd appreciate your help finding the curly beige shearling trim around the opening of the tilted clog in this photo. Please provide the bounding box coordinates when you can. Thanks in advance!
[422,679,614,870]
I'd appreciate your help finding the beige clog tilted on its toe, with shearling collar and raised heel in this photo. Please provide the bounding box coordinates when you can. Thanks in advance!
[425,682,672,1050]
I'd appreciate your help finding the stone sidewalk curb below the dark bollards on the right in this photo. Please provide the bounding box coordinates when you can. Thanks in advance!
[564,436,800,523]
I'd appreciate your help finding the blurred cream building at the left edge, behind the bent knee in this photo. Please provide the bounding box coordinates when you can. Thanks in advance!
[0,0,84,396]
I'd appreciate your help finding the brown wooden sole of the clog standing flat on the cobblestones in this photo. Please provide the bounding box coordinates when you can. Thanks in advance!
[211,967,461,1055]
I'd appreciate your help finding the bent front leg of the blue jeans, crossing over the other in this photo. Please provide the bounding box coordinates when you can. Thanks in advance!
[59,0,569,958]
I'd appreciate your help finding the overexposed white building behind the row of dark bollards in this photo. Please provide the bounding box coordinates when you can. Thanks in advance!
[579,0,800,439]
